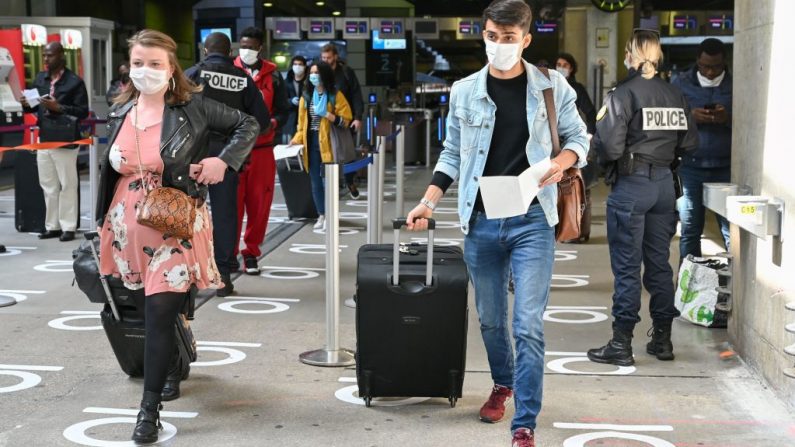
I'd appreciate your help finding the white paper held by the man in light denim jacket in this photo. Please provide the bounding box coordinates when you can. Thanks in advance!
[480,158,551,219]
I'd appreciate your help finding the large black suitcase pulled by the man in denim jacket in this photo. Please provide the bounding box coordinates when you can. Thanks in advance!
[356,219,468,407]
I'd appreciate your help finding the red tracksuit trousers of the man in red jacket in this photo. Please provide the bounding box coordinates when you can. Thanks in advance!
[235,146,276,258]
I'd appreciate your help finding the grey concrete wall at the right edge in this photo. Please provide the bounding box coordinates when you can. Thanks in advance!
[729,0,795,407]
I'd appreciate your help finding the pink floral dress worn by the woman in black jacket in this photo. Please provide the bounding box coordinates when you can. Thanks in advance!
[100,116,223,295]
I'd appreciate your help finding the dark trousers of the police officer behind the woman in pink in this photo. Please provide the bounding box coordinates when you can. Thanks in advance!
[209,169,240,276]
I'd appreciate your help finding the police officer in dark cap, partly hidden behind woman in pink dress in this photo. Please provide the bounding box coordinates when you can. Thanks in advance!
[185,32,271,297]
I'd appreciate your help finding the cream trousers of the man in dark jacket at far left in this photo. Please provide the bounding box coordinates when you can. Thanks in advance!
[36,148,80,231]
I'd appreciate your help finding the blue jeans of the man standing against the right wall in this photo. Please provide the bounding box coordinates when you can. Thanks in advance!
[676,166,731,259]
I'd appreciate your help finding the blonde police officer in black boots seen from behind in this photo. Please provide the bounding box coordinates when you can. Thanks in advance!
[588,30,698,366]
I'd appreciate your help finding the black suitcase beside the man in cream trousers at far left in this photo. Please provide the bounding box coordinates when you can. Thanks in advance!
[14,151,47,233]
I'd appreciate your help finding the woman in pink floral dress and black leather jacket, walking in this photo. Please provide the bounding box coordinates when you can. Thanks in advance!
[97,30,259,443]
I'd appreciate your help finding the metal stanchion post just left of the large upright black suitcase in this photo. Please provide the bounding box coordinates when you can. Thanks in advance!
[298,163,356,366]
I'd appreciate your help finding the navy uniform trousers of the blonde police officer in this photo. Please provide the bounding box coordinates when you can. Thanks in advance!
[607,163,679,331]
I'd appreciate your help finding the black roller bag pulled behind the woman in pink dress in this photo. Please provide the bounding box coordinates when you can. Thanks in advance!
[73,232,196,379]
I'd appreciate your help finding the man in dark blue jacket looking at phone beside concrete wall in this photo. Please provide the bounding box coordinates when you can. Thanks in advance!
[672,38,732,259]
